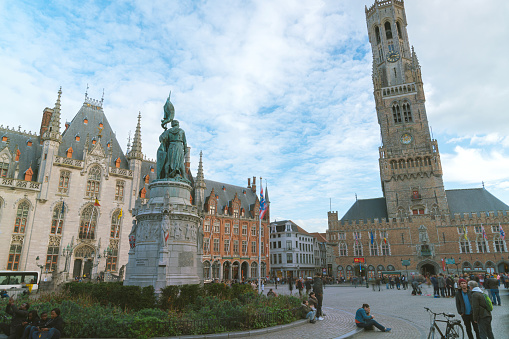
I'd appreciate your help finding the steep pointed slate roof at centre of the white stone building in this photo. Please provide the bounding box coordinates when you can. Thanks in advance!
[58,98,129,169]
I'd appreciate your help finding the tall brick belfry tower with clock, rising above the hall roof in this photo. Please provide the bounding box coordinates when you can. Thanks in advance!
[366,0,449,218]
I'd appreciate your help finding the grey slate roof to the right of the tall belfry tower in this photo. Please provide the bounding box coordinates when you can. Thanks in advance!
[445,188,509,215]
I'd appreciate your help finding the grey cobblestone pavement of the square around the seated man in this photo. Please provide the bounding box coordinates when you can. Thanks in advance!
[254,285,509,339]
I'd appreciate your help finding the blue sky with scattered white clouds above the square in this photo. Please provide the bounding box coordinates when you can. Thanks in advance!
[0,0,509,232]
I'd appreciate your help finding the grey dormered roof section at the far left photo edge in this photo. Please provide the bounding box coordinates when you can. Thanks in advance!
[0,127,42,181]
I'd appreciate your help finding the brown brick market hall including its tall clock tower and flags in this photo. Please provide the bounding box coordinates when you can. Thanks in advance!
[327,0,509,278]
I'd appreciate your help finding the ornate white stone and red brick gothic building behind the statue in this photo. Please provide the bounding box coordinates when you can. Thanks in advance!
[0,91,269,279]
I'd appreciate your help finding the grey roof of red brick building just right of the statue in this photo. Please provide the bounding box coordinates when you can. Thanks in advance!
[205,179,258,215]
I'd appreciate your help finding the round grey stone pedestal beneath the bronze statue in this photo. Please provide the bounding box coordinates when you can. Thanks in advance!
[124,180,202,293]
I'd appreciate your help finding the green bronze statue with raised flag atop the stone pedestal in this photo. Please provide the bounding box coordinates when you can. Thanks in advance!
[157,93,189,182]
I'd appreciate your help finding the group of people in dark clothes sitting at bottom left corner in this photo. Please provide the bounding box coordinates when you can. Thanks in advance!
[0,298,64,339]
